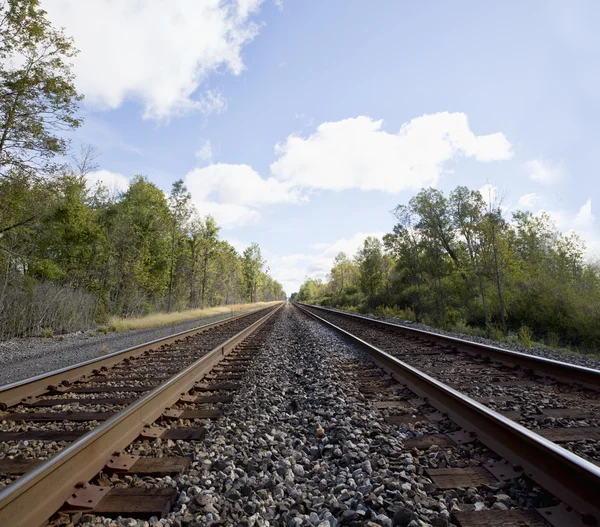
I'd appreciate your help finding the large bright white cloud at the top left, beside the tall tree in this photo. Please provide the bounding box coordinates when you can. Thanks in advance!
[43,0,262,118]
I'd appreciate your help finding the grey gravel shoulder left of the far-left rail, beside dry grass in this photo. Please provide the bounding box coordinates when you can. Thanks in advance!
[0,313,258,386]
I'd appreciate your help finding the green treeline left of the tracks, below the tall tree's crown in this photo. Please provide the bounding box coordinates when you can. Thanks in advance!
[0,172,285,337]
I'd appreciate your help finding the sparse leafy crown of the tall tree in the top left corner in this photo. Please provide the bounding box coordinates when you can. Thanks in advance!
[0,0,82,177]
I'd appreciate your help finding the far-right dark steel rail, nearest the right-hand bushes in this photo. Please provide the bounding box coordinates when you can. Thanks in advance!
[295,302,600,391]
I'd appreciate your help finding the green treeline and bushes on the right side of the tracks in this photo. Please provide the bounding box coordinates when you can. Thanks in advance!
[295,187,600,350]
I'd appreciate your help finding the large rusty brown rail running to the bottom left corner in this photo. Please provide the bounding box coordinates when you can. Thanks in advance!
[0,303,283,527]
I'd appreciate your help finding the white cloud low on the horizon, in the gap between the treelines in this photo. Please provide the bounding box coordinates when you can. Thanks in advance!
[267,232,384,295]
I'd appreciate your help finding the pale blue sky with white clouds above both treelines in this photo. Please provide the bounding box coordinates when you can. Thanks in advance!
[43,0,600,293]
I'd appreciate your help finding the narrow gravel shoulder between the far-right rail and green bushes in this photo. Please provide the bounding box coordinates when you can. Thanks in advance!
[316,308,600,370]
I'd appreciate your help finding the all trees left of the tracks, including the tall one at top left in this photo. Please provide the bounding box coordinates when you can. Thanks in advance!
[0,0,284,338]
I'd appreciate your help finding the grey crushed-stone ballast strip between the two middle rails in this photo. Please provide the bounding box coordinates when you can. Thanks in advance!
[76,306,556,527]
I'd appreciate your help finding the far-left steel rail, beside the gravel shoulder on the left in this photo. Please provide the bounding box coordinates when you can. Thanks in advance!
[0,306,273,410]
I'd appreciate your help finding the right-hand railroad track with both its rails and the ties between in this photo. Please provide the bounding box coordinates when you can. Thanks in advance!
[302,306,600,525]
